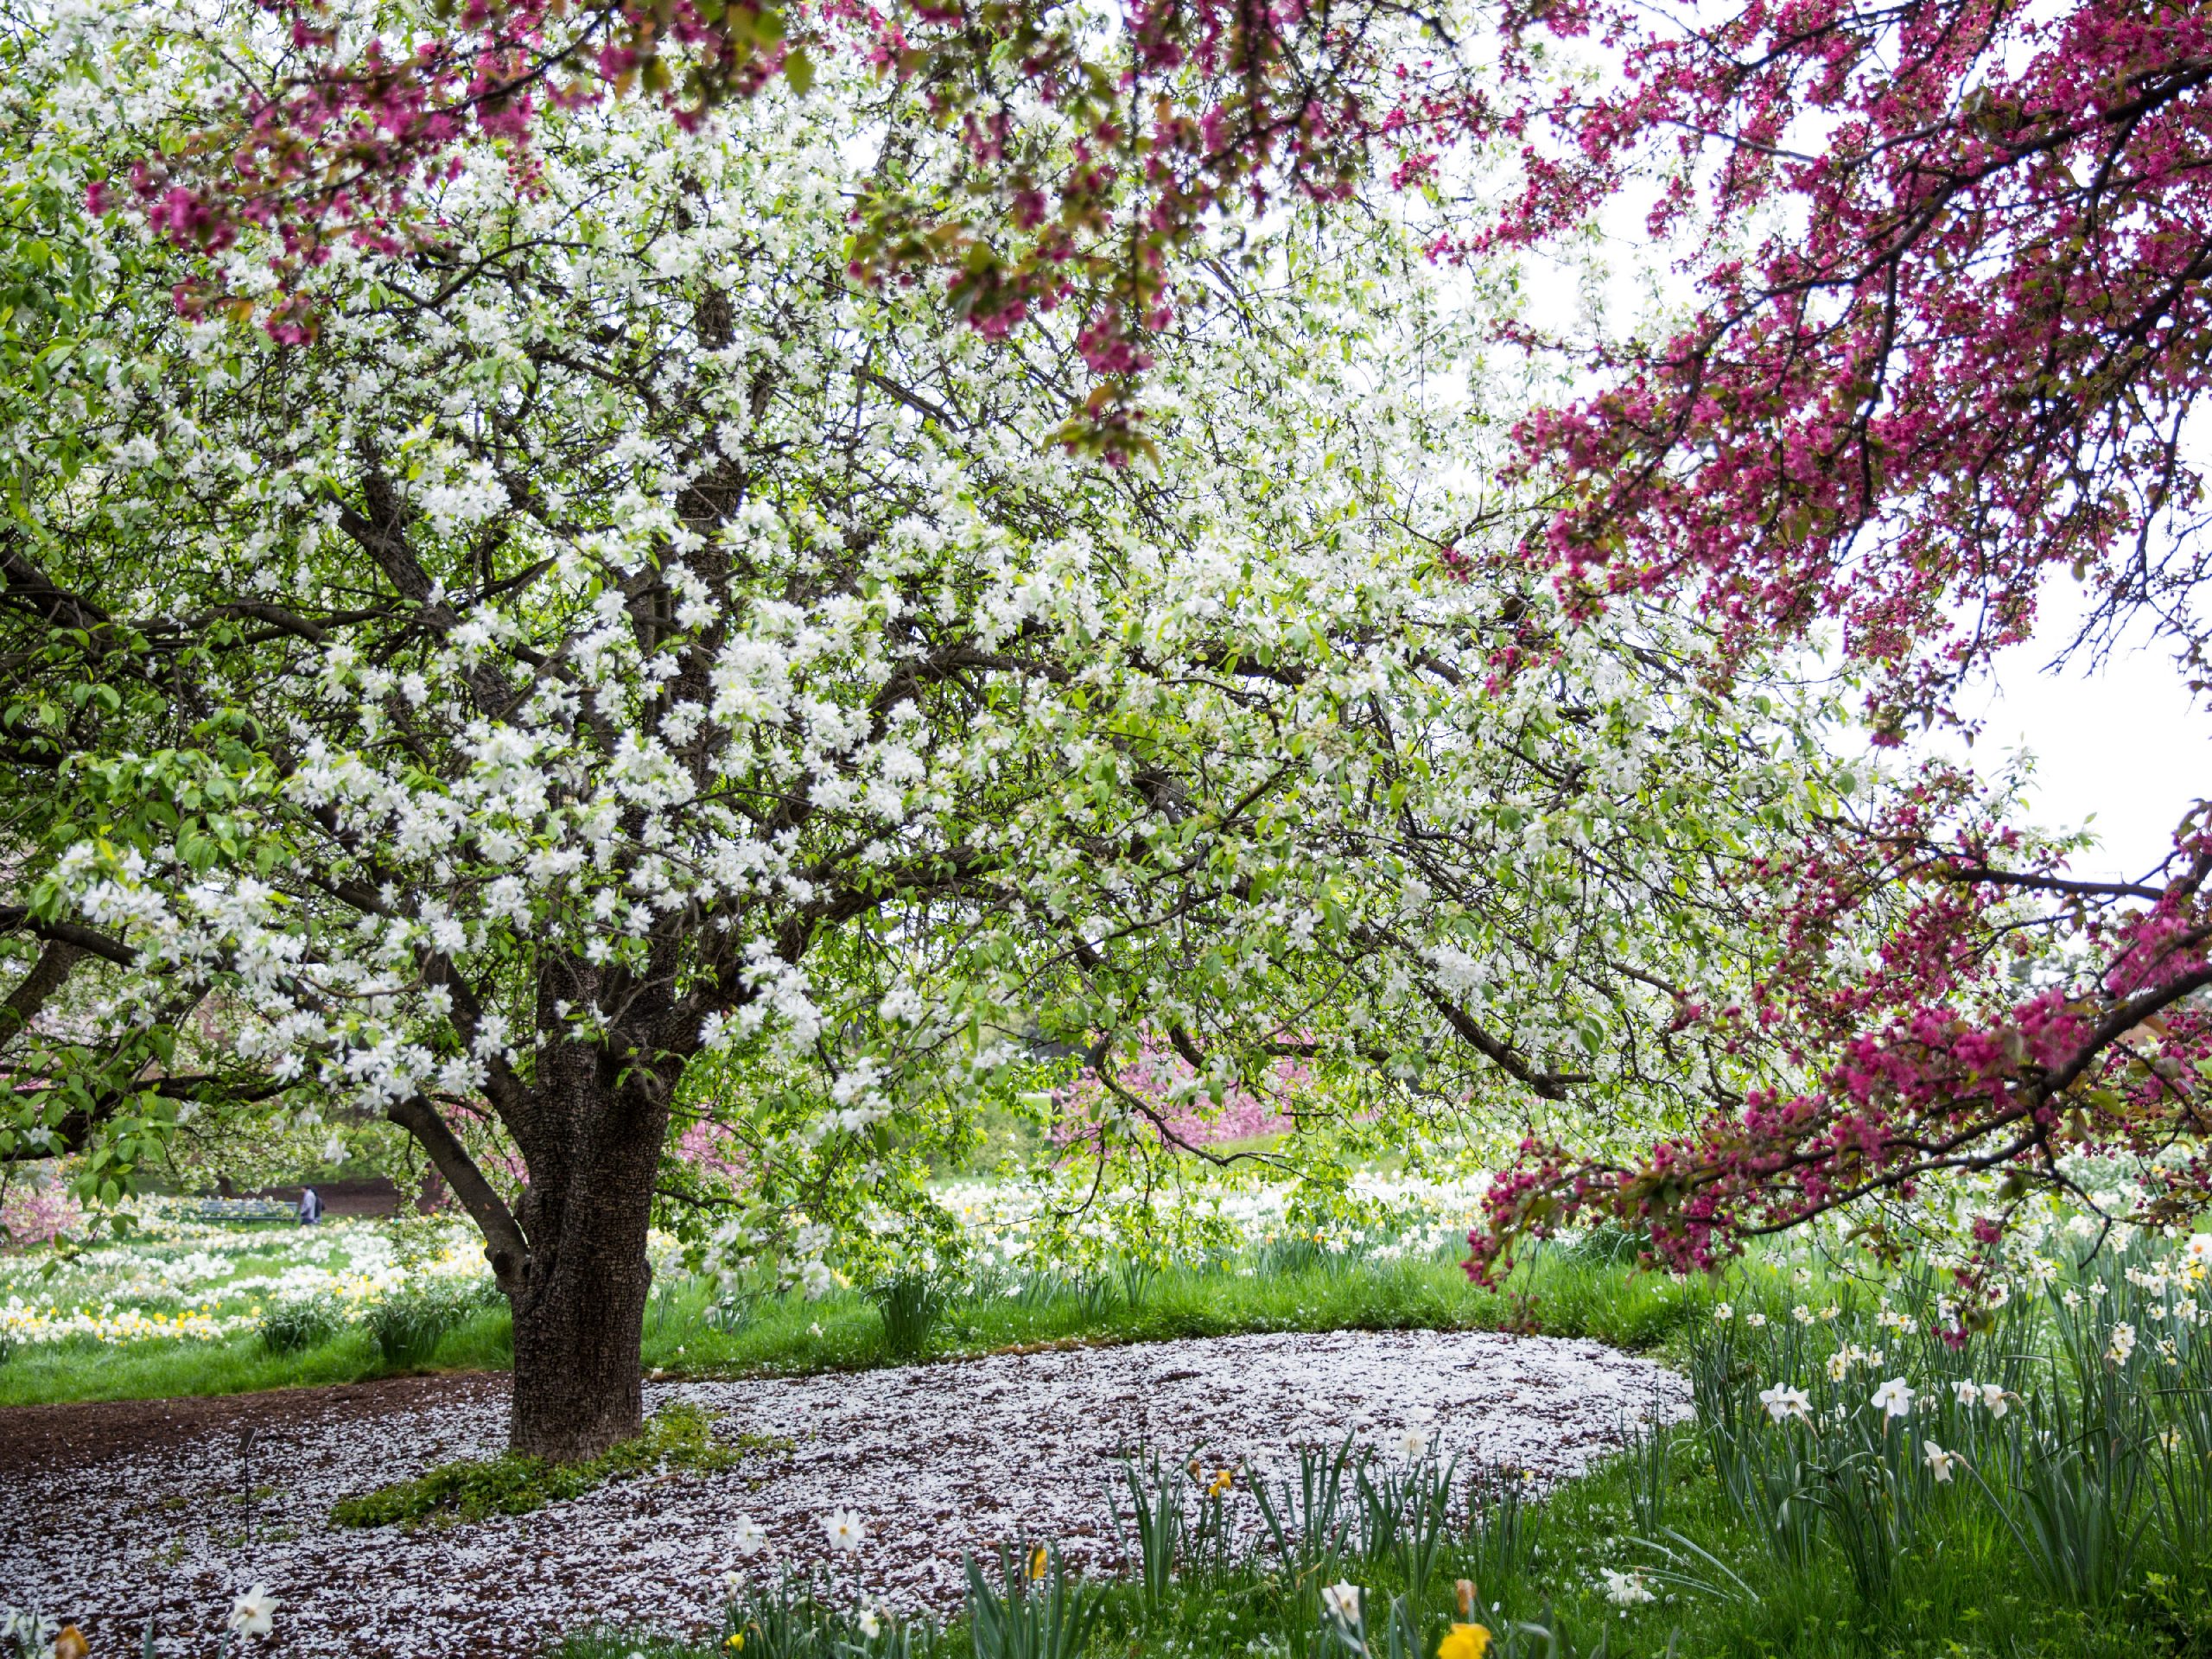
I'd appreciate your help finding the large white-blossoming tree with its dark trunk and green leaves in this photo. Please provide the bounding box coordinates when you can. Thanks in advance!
[0,11,1847,1458]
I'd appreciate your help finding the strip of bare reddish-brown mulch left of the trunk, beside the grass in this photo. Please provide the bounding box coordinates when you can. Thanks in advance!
[0,1371,506,1484]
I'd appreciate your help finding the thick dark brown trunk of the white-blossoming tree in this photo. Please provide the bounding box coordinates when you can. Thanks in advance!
[509,1077,668,1462]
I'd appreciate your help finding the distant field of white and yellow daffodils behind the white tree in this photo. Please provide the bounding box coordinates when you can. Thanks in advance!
[0,1168,2212,1354]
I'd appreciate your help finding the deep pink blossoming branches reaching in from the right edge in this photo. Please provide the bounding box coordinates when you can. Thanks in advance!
[1451,0,2212,1300]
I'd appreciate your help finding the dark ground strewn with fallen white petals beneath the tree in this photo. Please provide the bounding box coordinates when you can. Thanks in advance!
[0,1332,1688,1659]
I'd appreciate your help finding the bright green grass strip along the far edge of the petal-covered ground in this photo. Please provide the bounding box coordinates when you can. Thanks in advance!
[0,1249,1719,1405]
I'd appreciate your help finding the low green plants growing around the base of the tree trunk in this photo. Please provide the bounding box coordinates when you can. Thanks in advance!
[329,1405,785,1526]
